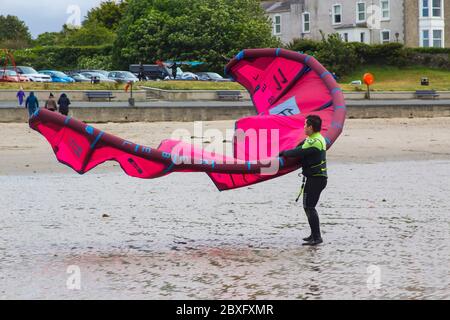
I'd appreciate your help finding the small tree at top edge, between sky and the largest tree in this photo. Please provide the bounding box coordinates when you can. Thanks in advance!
[83,0,128,30]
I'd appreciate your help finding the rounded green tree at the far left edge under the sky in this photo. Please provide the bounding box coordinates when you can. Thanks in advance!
[0,15,31,49]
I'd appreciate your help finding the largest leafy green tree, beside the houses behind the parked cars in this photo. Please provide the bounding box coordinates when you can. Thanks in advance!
[114,0,280,71]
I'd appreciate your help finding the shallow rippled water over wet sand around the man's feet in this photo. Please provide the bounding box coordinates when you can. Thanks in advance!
[0,160,450,299]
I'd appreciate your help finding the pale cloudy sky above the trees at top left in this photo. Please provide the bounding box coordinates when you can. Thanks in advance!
[0,0,102,38]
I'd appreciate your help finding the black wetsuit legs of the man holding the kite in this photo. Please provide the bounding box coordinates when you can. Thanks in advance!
[303,177,328,240]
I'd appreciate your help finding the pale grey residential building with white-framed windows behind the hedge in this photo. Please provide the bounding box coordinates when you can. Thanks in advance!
[262,0,450,47]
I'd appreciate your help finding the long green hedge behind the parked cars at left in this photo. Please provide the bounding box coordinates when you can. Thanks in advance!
[9,45,112,70]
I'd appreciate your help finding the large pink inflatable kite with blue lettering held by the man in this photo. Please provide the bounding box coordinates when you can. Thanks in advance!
[30,49,346,191]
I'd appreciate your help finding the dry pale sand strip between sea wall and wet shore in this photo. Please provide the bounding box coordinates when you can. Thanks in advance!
[0,118,450,175]
